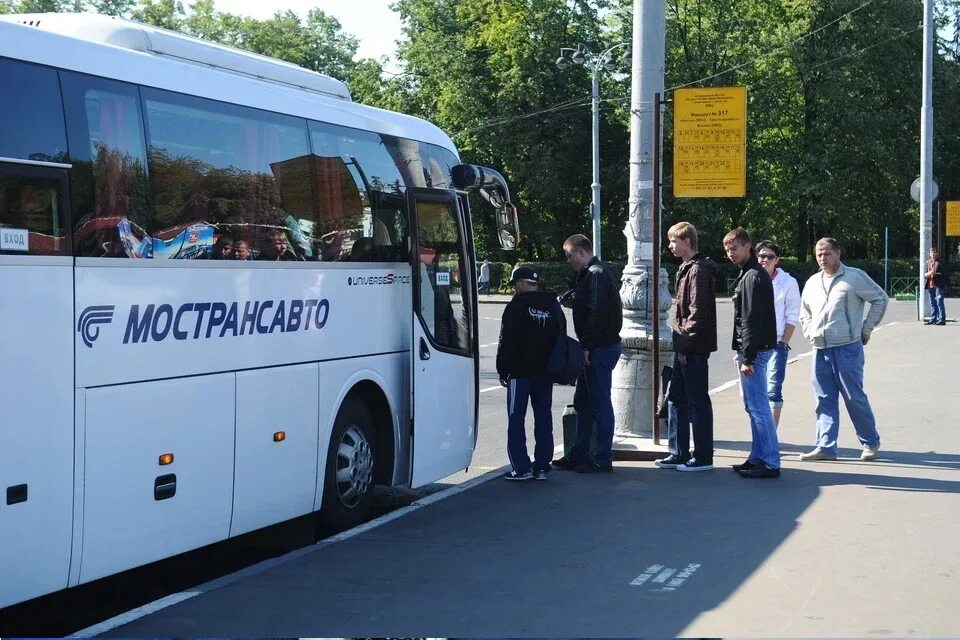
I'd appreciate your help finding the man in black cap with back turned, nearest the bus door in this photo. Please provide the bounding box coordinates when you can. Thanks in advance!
[497,265,567,480]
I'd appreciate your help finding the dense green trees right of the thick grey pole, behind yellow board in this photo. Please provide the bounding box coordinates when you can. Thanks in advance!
[648,0,960,257]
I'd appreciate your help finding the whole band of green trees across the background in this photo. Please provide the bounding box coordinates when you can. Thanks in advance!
[13,0,960,273]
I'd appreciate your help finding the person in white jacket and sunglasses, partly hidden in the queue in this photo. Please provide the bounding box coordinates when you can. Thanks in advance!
[757,240,800,427]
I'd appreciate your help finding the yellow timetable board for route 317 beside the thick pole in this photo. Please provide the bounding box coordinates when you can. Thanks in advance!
[673,87,747,198]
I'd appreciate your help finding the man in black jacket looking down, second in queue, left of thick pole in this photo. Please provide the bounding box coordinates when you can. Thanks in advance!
[553,234,623,473]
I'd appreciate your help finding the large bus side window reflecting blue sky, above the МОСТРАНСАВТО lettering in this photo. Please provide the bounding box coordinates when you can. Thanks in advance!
[142,88,316,260]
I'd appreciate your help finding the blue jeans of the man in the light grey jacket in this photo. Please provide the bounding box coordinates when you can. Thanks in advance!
[813,342,880,455]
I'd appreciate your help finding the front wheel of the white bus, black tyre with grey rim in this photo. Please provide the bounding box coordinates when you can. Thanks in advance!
[320,397,375,535]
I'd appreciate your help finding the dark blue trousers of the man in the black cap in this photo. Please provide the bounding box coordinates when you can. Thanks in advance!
[507,376,553,474]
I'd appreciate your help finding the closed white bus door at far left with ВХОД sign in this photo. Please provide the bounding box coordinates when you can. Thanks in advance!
[0,158,74,608]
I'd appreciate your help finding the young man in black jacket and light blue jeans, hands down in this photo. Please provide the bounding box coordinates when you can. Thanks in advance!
[723,227,780,478]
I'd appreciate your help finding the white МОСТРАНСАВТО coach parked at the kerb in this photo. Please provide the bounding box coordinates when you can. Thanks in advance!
[0,14,518,607]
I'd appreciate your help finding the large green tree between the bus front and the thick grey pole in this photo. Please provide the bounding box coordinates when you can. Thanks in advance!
[395,0,626,259]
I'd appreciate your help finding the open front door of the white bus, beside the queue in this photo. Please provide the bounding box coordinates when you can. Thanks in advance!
[410,189,477,487]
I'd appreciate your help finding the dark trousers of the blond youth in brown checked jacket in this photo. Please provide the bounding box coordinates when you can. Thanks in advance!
[667,353,713,464]
